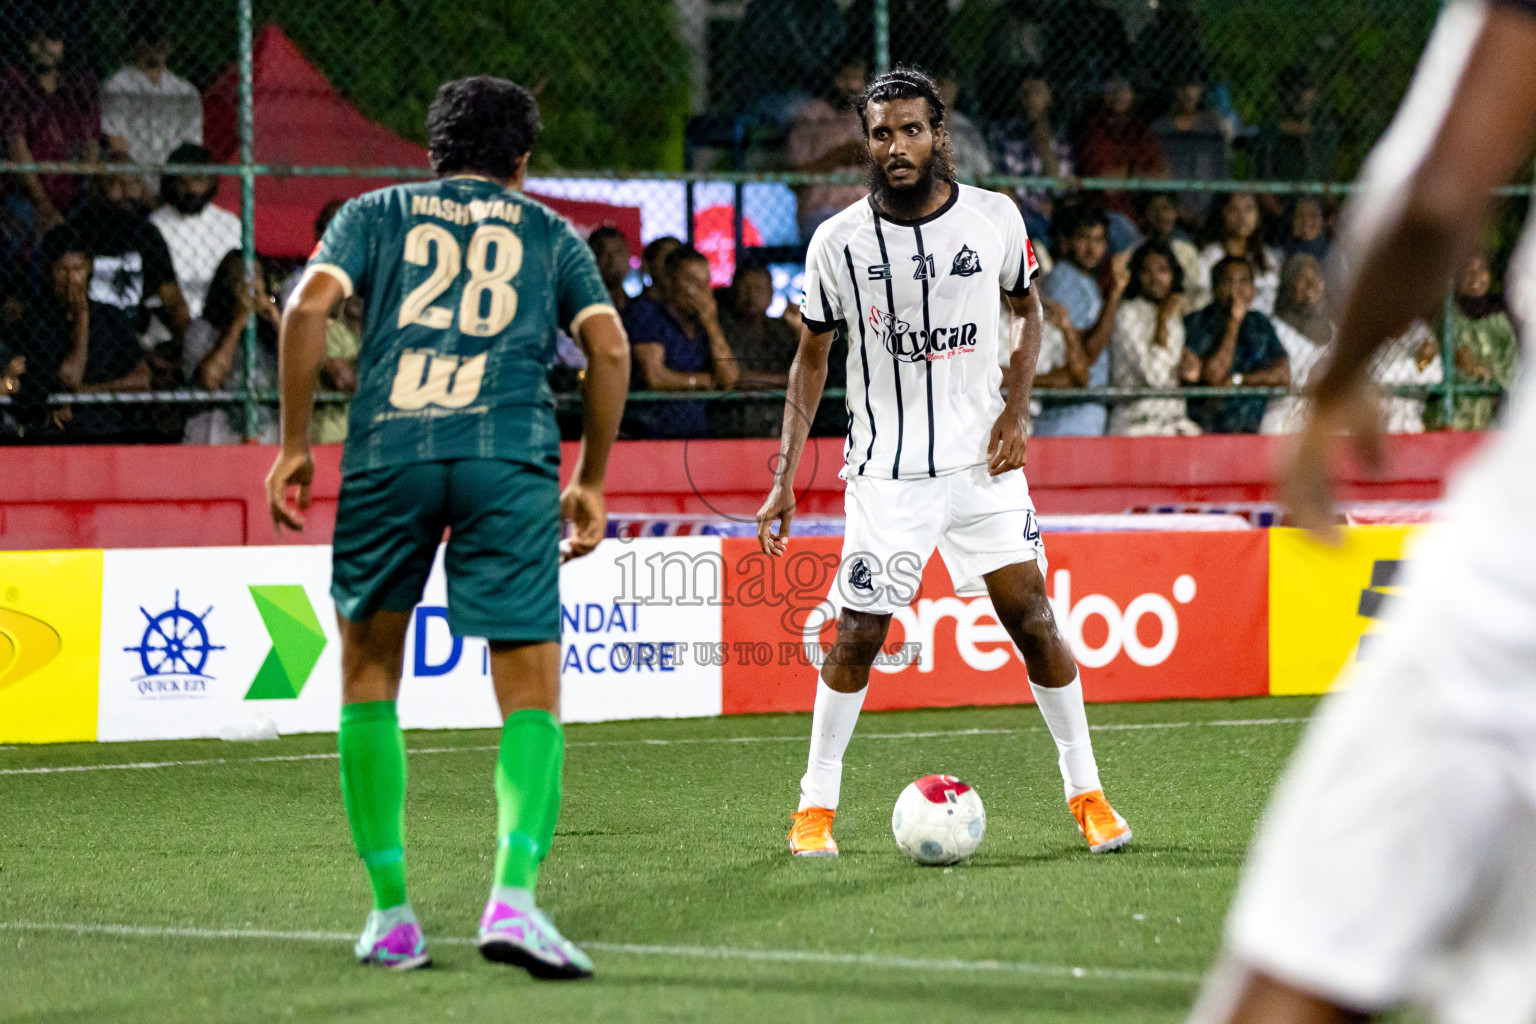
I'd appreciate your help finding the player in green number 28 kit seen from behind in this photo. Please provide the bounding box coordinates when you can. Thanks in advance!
[267,77,630,978]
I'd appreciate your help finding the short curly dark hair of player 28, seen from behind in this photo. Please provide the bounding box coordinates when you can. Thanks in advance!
[427,75,544,178]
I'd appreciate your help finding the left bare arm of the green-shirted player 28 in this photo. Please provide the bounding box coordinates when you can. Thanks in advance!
[267,264,344,533]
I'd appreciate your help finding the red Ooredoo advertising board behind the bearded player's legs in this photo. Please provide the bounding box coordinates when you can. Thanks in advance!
[722,530,1269,714]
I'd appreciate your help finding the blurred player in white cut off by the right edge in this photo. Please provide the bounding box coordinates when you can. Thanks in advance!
[1190,0,1536,1024]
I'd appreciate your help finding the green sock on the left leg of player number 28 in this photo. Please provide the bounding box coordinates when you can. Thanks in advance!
[336,700,408,910]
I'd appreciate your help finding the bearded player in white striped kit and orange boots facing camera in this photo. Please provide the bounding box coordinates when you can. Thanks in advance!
[757,68,1130,857]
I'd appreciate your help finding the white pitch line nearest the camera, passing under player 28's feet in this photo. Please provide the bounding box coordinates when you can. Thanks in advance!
[0,921,1200,984]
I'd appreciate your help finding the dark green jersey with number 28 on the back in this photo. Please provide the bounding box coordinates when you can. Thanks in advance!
[309,177,613,474]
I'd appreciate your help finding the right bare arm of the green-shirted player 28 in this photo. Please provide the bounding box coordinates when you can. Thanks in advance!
[561,313,630,559]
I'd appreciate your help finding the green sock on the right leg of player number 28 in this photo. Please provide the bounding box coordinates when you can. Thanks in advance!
[496,708,565,890]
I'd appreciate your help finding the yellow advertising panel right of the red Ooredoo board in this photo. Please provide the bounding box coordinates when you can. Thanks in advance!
[1269,527,1415,695]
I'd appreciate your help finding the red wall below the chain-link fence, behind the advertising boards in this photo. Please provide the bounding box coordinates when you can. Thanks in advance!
[0,431,1482,551]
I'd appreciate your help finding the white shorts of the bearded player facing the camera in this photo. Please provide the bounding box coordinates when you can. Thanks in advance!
[828,465,1046,614]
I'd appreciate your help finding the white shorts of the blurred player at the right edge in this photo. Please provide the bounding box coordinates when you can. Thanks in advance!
[1190,643,1536,1024]
